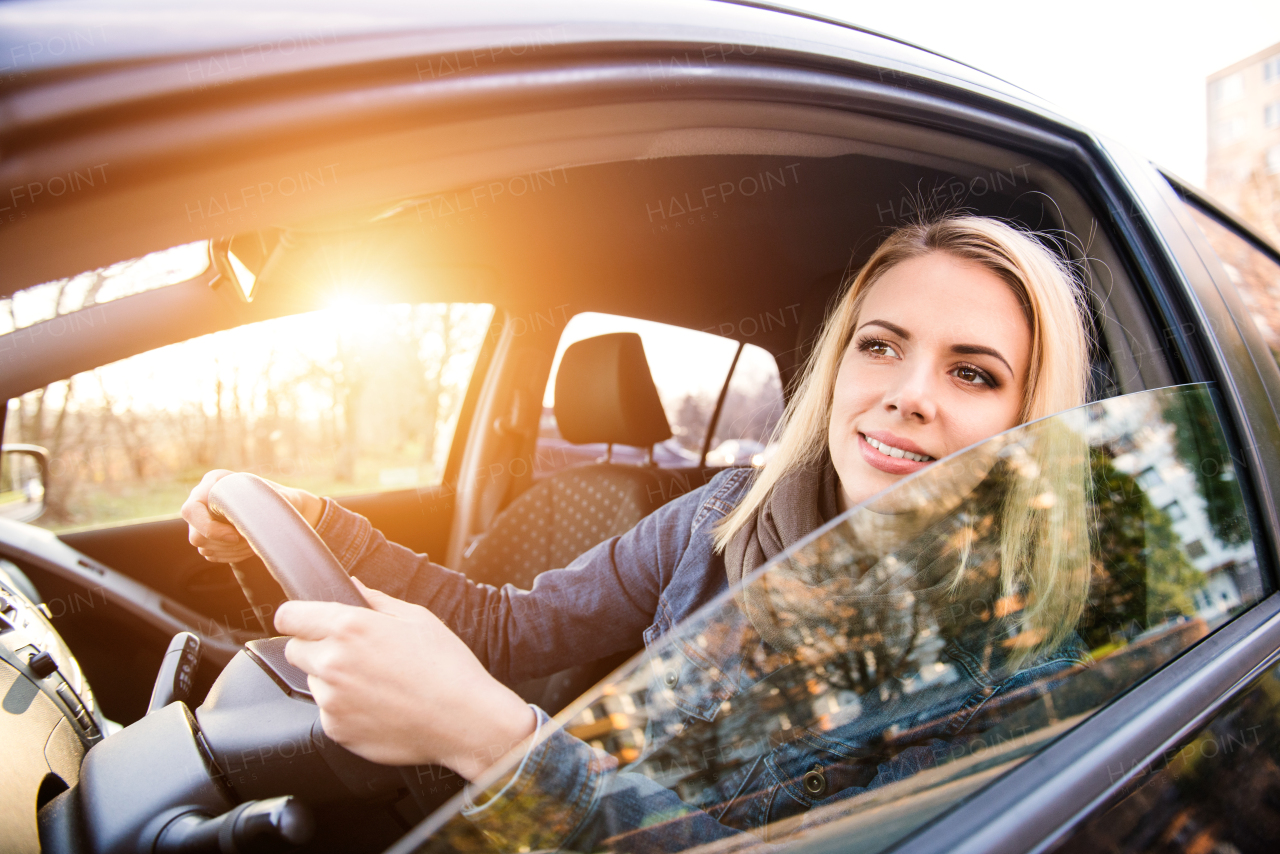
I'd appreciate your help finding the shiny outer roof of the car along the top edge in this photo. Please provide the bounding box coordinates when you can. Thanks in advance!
[0,0,1065,123]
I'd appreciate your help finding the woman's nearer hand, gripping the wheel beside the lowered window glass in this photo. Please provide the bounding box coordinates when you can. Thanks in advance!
[275,579,535,780]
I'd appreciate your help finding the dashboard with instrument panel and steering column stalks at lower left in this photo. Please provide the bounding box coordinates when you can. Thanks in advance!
[0,520,407,854]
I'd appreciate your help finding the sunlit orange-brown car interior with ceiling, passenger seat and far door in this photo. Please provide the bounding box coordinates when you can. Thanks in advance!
[0,92,1239,850]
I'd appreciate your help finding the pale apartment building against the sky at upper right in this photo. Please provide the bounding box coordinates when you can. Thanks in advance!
[1204,42,1280,245]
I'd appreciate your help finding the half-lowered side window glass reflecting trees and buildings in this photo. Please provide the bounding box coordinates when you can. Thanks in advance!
[397,385,1262,851]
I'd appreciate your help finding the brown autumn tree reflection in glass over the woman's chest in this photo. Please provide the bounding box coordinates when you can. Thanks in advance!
[637,471,1020,814]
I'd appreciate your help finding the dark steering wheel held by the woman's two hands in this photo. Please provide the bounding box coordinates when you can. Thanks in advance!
[197,472,456,829]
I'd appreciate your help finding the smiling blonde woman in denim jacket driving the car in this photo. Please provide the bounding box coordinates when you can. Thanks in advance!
[183,216,1089,850]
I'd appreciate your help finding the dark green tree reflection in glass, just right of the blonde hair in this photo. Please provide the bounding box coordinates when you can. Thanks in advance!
[1078,453,1203,649]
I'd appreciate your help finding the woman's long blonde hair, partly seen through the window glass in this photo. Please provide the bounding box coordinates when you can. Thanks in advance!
[716,215,1092,663]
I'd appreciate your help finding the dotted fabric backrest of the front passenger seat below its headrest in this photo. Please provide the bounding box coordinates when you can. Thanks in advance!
[461,465,672,590]
